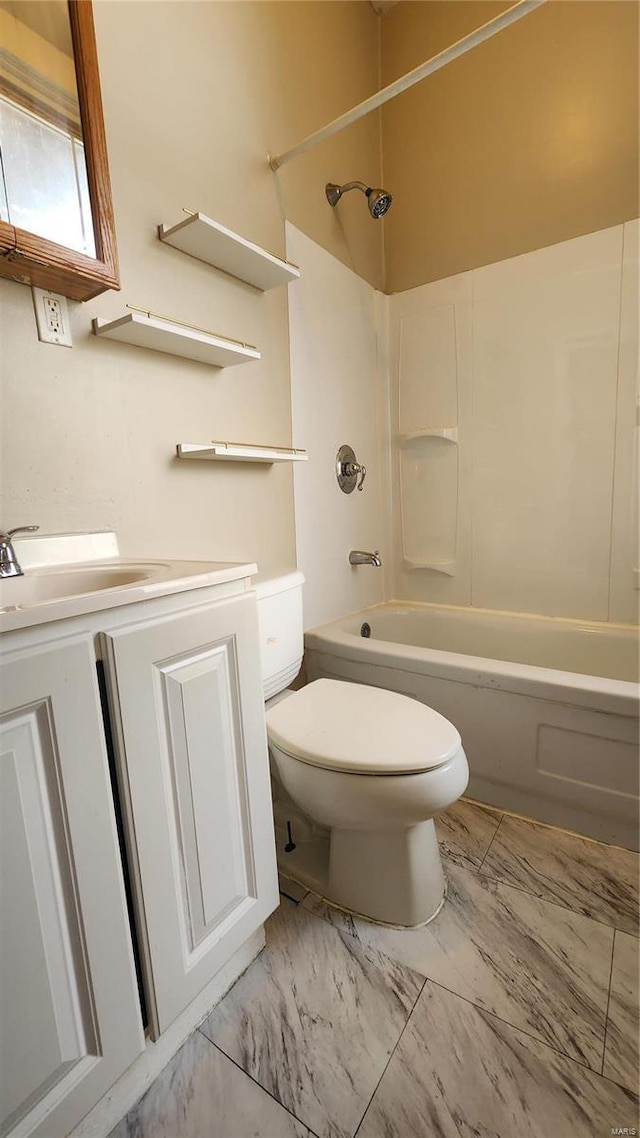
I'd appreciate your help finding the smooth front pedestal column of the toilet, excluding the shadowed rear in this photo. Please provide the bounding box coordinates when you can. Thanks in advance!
[327,818,444,927]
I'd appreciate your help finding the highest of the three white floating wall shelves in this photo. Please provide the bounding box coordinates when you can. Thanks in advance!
[158,213,300,292]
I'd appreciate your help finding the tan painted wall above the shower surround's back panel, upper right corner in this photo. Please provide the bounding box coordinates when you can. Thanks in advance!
[381,0,639,292]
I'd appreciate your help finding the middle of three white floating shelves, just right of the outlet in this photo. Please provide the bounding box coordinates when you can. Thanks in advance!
[93,312,262,368]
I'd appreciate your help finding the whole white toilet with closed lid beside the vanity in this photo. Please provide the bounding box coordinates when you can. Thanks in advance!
[256,572,469,927]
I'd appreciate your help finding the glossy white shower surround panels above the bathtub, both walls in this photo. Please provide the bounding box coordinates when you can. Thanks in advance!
[287,221,640,627]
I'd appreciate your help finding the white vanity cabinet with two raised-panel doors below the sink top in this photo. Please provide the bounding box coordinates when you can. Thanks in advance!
[0,567,278,1138]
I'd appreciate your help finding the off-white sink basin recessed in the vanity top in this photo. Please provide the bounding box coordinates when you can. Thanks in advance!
[0,566,158,612]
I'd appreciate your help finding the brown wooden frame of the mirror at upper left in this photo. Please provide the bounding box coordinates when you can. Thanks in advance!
[0,0,120,300]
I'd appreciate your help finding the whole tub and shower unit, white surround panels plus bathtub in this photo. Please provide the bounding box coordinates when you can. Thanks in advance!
[287,222,640,844]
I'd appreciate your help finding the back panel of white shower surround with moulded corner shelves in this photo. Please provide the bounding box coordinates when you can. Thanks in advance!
[388,222,640,621]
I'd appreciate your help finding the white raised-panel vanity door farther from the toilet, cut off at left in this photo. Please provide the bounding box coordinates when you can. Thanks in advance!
[0,636,145,1138]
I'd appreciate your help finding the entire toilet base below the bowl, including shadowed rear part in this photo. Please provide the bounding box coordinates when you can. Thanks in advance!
[278,820,446,929]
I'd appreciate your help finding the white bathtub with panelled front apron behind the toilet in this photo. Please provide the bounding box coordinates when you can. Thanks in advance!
[305,602,640,849]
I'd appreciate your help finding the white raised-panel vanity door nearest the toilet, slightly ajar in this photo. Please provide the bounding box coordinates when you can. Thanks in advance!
[104,594,278,1034]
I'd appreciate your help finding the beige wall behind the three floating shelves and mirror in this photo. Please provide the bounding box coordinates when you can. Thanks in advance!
[0,0,381,568]
